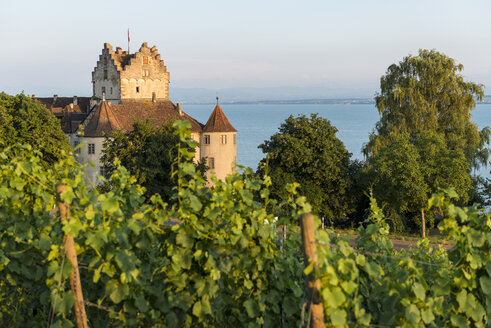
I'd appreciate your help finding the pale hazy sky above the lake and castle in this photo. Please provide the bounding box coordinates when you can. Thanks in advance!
[0,0,491,96]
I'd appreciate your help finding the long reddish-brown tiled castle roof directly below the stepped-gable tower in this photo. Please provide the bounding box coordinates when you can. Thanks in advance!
[84,100,203,137]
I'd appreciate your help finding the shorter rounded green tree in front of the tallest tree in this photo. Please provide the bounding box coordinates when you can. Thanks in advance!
[369,131,472,235]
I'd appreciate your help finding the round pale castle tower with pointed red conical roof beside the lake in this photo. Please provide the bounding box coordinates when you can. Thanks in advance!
[200,97,237,181]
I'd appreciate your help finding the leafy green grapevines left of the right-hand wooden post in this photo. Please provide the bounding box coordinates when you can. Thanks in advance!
[0,121,309,327]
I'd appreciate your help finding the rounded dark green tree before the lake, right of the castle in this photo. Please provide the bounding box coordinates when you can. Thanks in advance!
[259,114,351,219]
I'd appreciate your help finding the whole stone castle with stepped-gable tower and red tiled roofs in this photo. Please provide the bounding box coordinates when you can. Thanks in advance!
[37,42,237,183]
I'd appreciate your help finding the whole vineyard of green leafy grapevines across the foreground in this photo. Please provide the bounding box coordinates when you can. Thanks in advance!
[0,121,491,327]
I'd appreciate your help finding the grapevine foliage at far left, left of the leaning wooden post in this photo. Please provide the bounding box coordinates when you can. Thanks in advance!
[0,144,78,327]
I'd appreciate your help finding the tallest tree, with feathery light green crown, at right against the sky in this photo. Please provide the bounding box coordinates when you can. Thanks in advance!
[363,50,489,164]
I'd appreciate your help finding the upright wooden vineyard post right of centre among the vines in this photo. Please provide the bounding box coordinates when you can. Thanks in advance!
[300,213,325,328]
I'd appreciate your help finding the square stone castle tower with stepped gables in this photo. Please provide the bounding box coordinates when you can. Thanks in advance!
[92,42,170,104]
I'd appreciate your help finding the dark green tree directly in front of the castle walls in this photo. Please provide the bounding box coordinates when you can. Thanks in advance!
[101,120,205,201]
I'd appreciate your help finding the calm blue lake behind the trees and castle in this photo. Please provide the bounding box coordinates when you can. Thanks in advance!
[182,104,491,176]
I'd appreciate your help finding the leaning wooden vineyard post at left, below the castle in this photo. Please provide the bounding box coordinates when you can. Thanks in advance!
[56,183,88,328]
